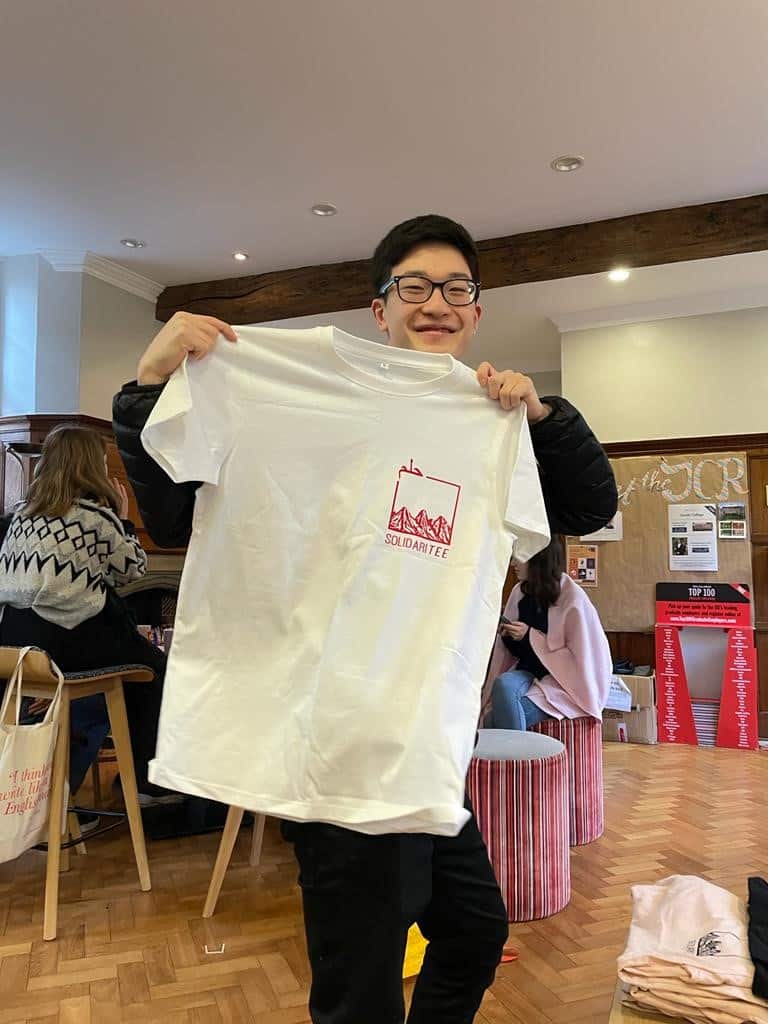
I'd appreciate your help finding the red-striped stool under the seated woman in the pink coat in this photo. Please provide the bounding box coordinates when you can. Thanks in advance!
[531,718,605,846]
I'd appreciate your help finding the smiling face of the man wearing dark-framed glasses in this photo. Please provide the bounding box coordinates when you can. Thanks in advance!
[373,244,481,359]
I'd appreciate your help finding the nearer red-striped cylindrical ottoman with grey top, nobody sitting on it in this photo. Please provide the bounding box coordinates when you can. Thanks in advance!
[467,729,570,921]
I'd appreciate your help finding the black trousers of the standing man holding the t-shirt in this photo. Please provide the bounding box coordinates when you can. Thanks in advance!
[283,803,508,1024]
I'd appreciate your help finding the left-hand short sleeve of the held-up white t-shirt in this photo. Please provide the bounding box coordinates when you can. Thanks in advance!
[141,349,232,484]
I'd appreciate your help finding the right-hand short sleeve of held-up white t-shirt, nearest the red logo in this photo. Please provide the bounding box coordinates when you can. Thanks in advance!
[499,406,550,562]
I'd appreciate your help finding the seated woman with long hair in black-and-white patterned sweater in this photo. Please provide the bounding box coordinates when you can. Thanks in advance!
[0,425,176,804]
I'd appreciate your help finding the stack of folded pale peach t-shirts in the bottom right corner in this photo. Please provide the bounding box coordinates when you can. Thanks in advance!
[618,874,768,1024]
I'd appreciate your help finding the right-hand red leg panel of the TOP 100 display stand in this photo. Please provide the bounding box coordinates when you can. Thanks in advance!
[717,630,758,751]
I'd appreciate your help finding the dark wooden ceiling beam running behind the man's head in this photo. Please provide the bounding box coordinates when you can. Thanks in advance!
[157,196,768,324]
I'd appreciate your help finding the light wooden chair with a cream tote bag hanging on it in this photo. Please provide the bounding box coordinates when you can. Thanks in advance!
[0,647,153,940]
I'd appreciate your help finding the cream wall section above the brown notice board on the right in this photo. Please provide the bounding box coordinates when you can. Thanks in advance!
[561,308,768,441]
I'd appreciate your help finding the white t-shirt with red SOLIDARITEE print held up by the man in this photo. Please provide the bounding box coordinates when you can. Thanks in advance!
[142,327,549,836]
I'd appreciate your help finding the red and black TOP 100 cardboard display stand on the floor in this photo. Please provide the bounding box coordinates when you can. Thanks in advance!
[656,583,758,751]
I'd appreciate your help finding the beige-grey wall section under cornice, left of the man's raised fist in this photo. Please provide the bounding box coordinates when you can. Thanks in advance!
[80,274,163,420]
